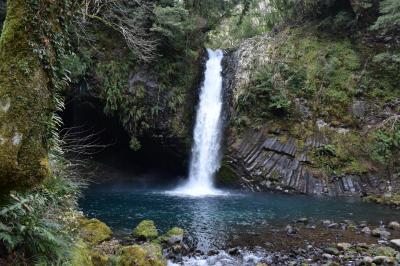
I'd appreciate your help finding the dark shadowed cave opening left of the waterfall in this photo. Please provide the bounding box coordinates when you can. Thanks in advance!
[61,92,188,180]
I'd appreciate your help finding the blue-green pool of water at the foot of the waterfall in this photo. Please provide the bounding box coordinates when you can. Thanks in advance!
[80,179,400,251]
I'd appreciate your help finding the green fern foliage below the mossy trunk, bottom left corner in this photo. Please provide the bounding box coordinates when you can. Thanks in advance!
[0,160,80,264]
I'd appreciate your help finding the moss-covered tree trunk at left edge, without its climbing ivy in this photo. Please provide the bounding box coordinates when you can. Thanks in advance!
[0,0,53,192]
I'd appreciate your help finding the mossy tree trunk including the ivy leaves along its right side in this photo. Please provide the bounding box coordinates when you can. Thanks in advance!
[0,0,69,191]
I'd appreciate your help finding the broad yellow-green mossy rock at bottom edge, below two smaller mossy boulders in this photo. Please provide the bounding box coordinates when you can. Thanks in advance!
[117,243,167,266]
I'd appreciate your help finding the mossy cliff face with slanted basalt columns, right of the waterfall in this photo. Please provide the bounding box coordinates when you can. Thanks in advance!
[219,24,400,196]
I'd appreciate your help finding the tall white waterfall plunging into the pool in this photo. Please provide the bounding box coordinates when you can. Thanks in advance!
[175,49,227,196]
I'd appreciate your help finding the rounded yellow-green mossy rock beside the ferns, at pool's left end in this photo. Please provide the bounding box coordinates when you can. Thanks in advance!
[79,218,112,245]
